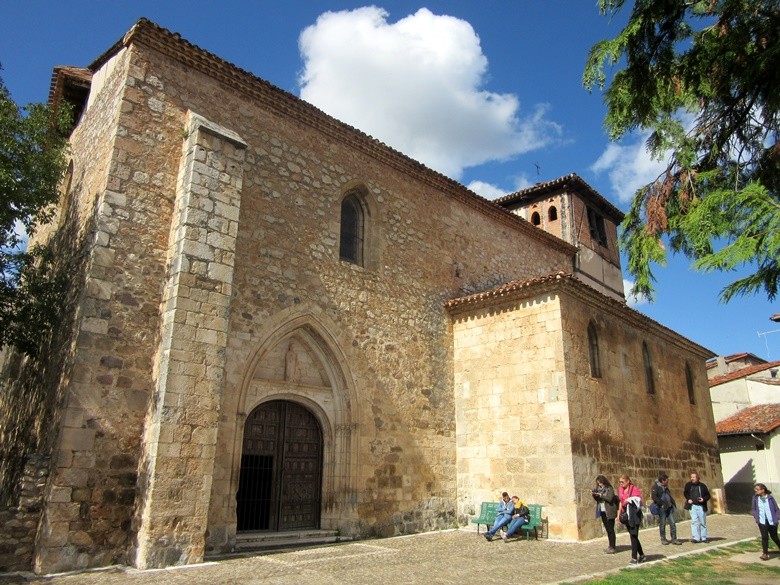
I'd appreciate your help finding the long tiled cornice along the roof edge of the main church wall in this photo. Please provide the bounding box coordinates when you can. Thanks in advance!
[89,18,577,256]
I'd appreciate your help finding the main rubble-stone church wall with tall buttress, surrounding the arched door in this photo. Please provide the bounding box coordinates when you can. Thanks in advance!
[19,28,572,572]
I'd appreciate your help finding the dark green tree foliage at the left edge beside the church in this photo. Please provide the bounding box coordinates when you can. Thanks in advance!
[0,73,70,355]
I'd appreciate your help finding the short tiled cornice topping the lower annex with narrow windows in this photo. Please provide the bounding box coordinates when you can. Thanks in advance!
[444,272,715,359]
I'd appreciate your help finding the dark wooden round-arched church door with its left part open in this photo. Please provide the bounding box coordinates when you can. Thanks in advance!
[236,400,322,532]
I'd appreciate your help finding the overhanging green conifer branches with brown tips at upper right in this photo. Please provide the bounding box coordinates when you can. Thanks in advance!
[583,0,780,301]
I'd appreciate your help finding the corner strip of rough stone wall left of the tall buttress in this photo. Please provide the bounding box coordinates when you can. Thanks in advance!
[35,44,182,573]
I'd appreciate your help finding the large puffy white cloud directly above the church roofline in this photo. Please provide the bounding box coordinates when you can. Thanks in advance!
[299,6,561,179]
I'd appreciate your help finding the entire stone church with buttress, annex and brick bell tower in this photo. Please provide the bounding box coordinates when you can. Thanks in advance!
[0,20,722,573]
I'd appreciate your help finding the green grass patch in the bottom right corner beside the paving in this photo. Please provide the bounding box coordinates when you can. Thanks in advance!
[570,540,780,585]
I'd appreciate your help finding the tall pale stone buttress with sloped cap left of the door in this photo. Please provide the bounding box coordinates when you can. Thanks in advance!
[134,113,246,569]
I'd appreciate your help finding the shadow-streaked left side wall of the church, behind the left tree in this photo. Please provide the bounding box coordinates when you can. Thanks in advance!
[0,50,129,569]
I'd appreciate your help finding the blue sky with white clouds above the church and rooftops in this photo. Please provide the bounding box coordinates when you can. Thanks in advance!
[0,0,780,360]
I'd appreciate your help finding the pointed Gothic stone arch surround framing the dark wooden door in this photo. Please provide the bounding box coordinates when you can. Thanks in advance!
[230,314,358,534]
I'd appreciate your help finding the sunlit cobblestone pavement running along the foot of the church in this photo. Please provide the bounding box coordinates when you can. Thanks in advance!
[0,514,780,585]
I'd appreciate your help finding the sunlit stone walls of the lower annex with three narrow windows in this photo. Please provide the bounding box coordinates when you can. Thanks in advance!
[451,278,723,539]
